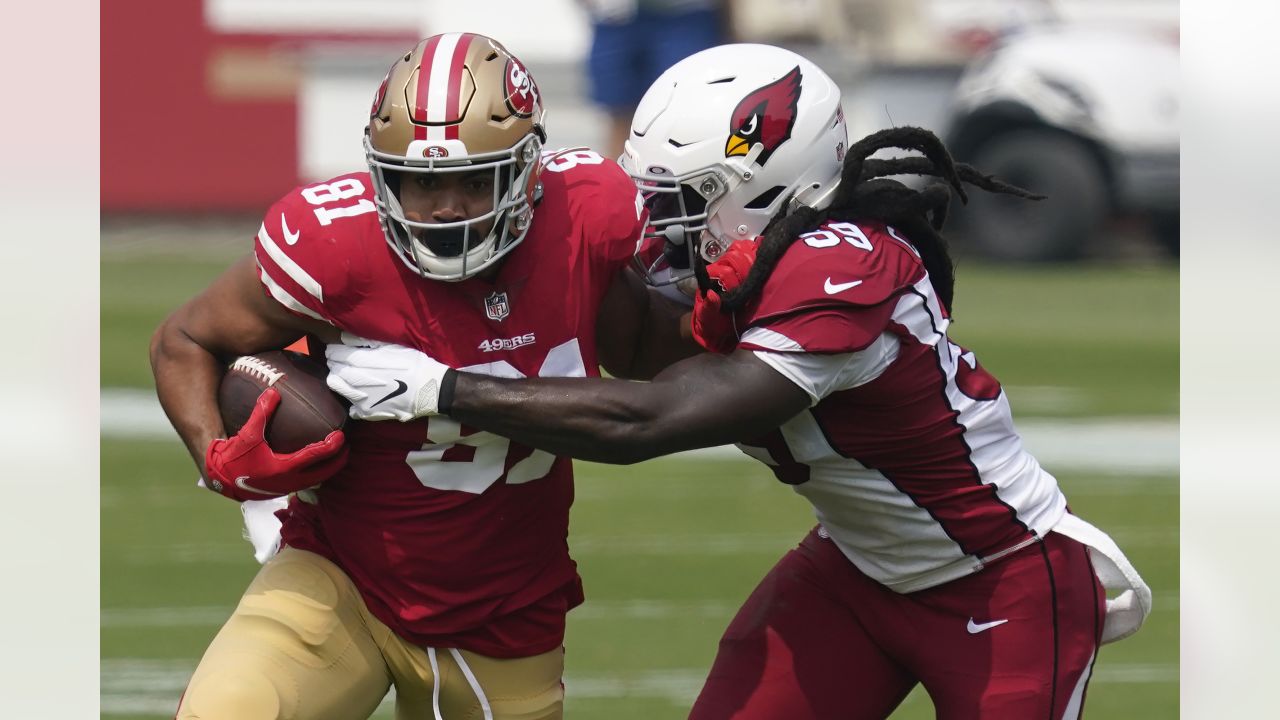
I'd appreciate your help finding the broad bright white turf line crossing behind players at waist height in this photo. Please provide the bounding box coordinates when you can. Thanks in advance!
[100,388,1178,473]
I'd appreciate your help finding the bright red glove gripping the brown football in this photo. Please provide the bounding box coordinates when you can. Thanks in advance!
[205,387,347,501]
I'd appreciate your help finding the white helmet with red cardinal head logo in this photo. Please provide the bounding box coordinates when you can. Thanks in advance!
[618,44,849,284]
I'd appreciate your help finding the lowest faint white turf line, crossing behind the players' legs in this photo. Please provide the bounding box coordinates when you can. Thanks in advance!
[100,659,1179,716]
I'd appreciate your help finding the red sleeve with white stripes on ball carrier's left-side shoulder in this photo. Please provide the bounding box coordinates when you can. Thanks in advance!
[253,173,375,324]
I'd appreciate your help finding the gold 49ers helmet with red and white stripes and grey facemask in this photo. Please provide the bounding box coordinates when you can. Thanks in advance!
[365,32,547,281]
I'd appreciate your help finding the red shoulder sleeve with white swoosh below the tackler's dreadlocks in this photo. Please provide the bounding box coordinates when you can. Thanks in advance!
[740,222,925,352]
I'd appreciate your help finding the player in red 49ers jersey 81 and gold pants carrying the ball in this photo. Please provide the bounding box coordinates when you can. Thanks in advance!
[151,33,698,720]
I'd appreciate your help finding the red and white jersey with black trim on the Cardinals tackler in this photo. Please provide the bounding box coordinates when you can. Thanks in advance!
[739,222,1066,593]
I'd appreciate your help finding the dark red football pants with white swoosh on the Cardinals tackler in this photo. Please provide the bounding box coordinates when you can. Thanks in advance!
[690,520,1106,720]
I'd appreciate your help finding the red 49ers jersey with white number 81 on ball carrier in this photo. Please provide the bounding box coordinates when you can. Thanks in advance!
[255,151,643,657]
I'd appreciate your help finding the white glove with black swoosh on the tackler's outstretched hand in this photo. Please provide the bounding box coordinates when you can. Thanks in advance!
[324,333,452,423]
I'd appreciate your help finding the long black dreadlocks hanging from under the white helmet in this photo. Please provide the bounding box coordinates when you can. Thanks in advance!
[716,127,1044,313]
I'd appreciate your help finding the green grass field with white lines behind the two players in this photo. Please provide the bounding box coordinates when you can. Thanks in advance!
[101,246,1179,720]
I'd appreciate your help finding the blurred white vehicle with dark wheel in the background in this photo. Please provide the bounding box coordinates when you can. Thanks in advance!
[945,24,1179,261]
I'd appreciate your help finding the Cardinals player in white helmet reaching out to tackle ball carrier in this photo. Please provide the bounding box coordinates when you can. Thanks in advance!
[326,45,1151,720]
